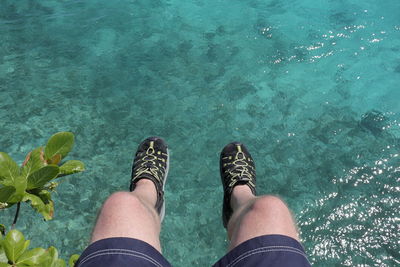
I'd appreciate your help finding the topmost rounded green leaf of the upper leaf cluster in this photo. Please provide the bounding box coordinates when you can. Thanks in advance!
[44,132,74,160]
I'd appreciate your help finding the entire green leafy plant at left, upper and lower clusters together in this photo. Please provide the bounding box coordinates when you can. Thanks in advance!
[0,132,85,267]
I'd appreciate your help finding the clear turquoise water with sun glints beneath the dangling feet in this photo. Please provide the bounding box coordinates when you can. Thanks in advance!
[0,0,400,266]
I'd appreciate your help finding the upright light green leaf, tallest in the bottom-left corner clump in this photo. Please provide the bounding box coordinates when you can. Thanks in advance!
[3,230,29,262]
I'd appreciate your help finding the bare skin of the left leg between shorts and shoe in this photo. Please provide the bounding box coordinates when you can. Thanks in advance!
[91,179,161,252]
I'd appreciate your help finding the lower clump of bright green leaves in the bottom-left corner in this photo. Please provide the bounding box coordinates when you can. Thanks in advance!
[0,230,79,267]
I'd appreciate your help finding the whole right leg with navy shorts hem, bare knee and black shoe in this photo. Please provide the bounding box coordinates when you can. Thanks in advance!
[214,142,310,267]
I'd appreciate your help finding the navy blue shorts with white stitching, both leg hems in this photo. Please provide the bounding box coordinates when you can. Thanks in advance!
[75,235,311,267]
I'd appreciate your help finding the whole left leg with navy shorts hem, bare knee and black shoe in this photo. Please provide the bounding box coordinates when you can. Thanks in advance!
[76,137,170,267]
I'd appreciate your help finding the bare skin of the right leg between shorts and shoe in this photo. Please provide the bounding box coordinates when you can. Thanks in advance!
[227,185,299,249]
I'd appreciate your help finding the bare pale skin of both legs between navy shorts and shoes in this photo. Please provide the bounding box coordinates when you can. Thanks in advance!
[91,179,299,252]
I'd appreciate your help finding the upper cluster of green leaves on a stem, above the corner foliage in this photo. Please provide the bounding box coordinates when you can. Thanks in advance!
[0,132,84,225]
